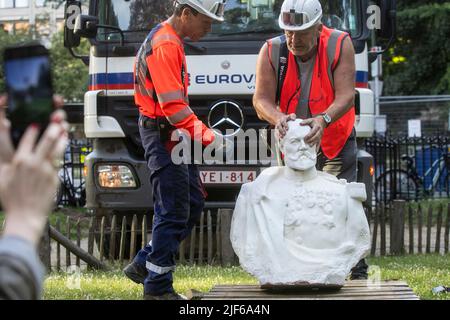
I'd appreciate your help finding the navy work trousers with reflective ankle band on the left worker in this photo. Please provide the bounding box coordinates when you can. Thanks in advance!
[134,115,206,295]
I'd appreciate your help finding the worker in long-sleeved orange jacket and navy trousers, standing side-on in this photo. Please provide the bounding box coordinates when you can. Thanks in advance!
[124,0,226,300]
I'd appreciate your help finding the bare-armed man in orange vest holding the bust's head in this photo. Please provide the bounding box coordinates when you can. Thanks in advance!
[253,0,367,279]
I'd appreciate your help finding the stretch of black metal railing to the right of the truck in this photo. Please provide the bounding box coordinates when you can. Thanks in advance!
[365,136,450,203]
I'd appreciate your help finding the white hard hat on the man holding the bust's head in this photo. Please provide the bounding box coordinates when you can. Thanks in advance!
[278,0,322,31]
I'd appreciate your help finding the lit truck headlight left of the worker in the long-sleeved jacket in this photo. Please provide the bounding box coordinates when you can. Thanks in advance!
[97,165,136,188]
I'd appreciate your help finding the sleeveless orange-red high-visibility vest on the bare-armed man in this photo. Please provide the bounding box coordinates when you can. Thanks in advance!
[267,26,355,159]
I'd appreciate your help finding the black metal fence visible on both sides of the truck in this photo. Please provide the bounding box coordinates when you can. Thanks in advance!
[60,135,450,207]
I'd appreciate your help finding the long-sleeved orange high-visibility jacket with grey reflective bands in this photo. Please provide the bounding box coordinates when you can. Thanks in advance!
[134,21,214,145]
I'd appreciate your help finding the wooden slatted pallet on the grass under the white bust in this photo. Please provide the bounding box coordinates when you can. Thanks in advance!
[202,280,419,300]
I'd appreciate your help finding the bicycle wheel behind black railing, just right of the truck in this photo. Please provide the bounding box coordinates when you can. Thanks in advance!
[375,170,419,203]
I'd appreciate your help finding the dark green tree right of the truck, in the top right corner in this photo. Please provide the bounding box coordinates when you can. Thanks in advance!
[384,0,450,95]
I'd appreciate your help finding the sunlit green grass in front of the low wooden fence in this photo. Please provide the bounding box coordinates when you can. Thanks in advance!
[44,255,450,300]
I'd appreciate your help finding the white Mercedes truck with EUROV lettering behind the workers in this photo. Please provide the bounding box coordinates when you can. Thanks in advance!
[64,0,395,254]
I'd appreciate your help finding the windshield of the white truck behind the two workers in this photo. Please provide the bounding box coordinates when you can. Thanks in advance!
[98,0,361,41]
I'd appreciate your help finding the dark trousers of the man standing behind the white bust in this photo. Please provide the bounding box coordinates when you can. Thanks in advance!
[316,128,368,279]
